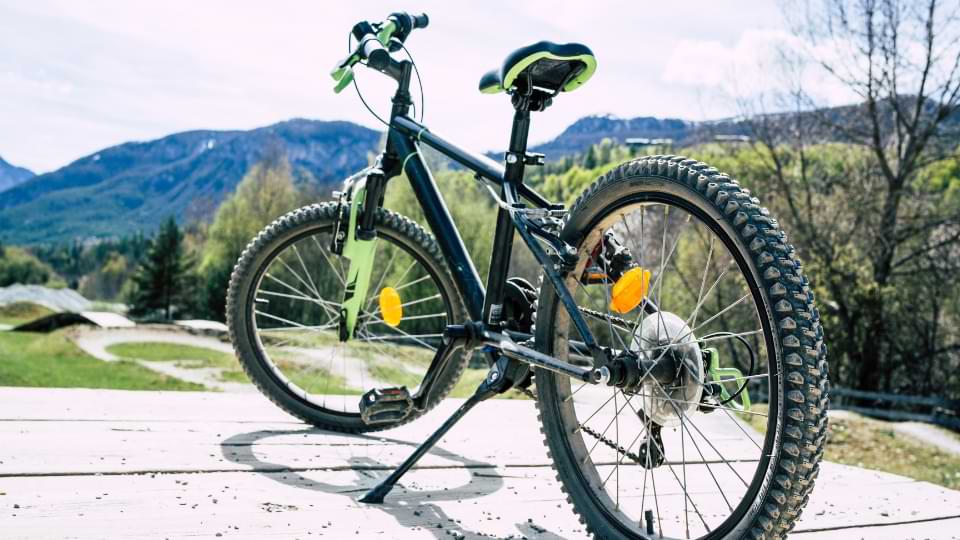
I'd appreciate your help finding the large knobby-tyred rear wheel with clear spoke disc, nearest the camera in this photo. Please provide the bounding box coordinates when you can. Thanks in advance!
[535,156,827,538]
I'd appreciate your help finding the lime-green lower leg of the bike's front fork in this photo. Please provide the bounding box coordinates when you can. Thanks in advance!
[340,179,377,341]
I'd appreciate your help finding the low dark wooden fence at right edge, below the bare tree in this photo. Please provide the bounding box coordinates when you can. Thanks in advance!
[830,388,960,430]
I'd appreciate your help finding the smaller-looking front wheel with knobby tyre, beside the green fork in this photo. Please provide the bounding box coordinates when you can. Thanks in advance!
[227,203,466,432]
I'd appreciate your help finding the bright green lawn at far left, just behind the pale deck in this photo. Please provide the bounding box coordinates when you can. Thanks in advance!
[0,332,206,390]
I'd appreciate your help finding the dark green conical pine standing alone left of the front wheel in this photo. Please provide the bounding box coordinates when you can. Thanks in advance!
[131,216,192,320]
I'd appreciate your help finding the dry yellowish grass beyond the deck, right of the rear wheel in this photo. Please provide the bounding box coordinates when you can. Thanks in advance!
[737,404,960,489]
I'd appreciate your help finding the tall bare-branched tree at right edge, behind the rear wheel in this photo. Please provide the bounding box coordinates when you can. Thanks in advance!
[750,0,960,392]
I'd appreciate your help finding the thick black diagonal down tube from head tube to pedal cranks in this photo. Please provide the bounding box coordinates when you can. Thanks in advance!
[393,137,485,321]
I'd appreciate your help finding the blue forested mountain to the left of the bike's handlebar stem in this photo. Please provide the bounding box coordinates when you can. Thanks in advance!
[0,119,380,244]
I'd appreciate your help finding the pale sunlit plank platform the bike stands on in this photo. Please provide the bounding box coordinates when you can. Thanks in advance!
[0,388,960,540]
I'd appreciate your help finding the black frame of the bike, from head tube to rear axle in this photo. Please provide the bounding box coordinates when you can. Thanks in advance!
[359,61,607,379]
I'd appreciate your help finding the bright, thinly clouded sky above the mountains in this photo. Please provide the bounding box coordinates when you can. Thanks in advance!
[0,0,856,173]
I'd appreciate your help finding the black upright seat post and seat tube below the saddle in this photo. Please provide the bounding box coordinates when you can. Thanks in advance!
[483,106,530,325]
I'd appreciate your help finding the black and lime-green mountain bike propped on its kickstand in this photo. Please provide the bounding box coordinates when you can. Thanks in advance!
[227,13,828,538]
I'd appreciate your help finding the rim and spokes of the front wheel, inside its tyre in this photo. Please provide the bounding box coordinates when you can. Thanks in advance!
[246,221,453,416]
